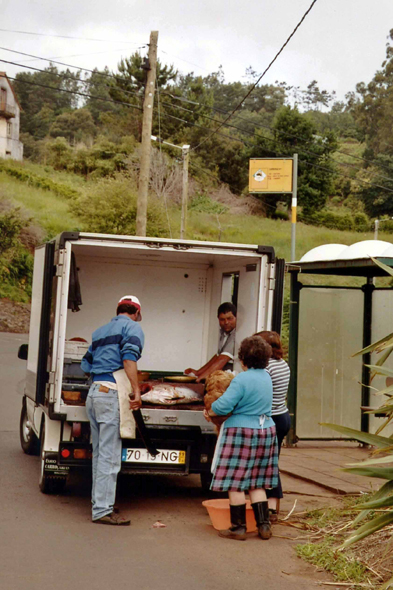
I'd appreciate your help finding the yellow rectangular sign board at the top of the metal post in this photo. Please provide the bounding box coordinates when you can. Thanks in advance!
[248,158,293,193]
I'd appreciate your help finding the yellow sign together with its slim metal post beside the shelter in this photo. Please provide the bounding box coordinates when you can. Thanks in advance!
[248,154,298,261]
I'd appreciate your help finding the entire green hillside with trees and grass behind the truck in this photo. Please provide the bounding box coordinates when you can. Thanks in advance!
[0,30,393,301]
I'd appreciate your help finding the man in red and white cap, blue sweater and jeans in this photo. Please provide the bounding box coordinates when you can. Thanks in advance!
[81,295,145,525]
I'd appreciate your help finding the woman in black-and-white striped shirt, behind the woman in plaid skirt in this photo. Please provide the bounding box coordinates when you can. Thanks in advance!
[256,331,291,522]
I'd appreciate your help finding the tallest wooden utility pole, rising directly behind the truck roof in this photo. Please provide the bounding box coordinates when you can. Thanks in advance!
[136,31,158,236]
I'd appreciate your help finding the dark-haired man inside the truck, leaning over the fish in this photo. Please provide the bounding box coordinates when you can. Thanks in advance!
[184,301,237,383]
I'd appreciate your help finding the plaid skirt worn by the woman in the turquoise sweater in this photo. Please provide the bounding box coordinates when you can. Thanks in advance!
[210,426,278,492]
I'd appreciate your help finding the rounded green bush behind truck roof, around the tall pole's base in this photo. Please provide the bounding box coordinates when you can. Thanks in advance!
[71,176,168,237]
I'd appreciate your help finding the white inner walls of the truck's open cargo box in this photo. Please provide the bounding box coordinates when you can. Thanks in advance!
[65,244,270,373]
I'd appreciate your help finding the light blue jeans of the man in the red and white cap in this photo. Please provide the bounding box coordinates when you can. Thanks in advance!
[86,383,121,520]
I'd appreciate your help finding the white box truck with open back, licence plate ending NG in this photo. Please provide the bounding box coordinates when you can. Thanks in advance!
[18,232,284,493]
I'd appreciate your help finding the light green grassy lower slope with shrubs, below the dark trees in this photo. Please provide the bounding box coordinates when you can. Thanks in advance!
[0,156,391,310]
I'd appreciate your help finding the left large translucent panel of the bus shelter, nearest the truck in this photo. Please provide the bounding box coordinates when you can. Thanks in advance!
[296,287,364,438]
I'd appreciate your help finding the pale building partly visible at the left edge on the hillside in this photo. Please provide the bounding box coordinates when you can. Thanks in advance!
[0,72,23,160]
